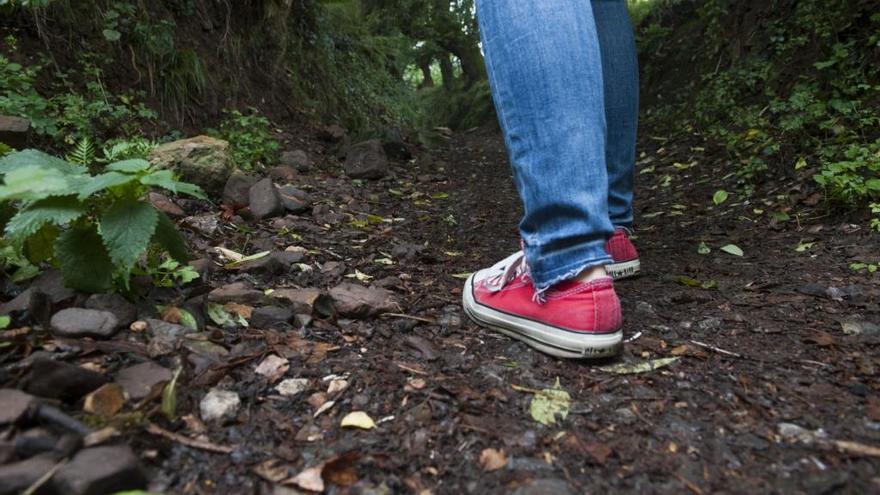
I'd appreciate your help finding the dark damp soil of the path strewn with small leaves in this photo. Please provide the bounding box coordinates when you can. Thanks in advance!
[0,129,880,494]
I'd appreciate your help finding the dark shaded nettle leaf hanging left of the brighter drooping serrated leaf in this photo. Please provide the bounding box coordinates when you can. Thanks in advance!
[55,225,113,292]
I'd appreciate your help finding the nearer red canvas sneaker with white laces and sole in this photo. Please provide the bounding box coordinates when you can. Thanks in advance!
[462,251,623,358]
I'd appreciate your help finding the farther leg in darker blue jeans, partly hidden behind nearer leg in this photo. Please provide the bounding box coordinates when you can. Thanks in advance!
[592,0,639,230]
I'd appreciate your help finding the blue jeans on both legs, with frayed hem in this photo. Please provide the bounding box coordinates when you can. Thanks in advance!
[477,0,638,291]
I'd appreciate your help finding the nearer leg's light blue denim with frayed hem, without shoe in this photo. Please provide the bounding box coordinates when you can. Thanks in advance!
[477,0,614,291]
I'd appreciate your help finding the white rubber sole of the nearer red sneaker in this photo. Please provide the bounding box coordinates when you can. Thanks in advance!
[462,274,623,359]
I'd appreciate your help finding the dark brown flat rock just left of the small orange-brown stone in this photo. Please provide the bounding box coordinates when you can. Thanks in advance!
[24,358,107,402]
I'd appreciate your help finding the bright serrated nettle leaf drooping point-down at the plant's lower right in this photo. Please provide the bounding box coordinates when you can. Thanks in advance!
[99,199,159,272]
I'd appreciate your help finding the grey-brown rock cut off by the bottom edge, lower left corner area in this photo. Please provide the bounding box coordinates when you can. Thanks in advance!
[52,445,147,495]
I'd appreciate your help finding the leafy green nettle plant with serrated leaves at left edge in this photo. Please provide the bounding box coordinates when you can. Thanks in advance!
[0,150,205,292]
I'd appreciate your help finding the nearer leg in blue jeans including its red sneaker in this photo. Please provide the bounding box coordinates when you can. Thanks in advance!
[462,0,623,358]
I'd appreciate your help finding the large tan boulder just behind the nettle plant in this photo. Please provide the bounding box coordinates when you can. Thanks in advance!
[147,136,235,196]
